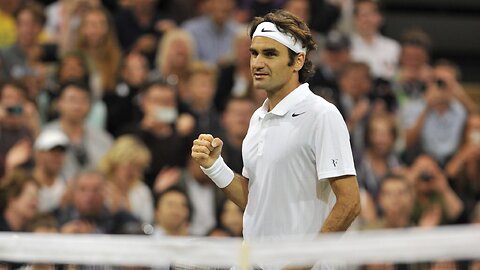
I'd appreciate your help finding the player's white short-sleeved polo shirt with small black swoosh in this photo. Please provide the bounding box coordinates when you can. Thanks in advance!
[242,83,356,239]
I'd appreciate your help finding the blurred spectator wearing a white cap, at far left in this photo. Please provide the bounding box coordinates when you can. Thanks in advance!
[32,129,69,212]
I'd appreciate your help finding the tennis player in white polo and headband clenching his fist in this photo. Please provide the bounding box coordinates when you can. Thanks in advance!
[192,10,360,243]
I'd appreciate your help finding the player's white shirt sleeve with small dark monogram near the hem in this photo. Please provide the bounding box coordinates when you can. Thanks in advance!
[314,108,356,180]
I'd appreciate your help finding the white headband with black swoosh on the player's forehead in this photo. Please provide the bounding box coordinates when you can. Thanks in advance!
[252,22,307,54]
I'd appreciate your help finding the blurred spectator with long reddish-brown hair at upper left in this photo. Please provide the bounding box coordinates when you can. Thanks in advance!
[76,7,121,98]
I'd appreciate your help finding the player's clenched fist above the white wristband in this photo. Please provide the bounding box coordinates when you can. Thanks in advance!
[192,134,223,168]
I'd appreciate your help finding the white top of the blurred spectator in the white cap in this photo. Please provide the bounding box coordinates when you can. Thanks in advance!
[38,177,66,213]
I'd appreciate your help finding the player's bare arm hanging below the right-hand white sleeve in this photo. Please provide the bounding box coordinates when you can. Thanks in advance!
[320,176,360,233]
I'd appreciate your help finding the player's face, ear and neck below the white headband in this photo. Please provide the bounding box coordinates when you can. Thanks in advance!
[250,37,305,110]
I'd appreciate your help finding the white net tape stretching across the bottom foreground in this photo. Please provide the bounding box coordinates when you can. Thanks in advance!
[0,226,480,267]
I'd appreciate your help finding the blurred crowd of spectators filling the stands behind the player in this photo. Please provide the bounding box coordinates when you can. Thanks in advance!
[0,0,480,268]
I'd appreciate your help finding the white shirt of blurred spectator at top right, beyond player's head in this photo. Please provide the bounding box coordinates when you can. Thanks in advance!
[351,34,400,80]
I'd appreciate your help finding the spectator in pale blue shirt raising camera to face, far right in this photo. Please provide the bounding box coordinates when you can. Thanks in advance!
[401,60,477,167]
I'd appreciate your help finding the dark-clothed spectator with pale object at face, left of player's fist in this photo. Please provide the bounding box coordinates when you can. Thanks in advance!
[119,82,195,187]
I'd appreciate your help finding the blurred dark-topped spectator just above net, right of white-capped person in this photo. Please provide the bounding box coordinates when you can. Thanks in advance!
[54,171,141,234]
